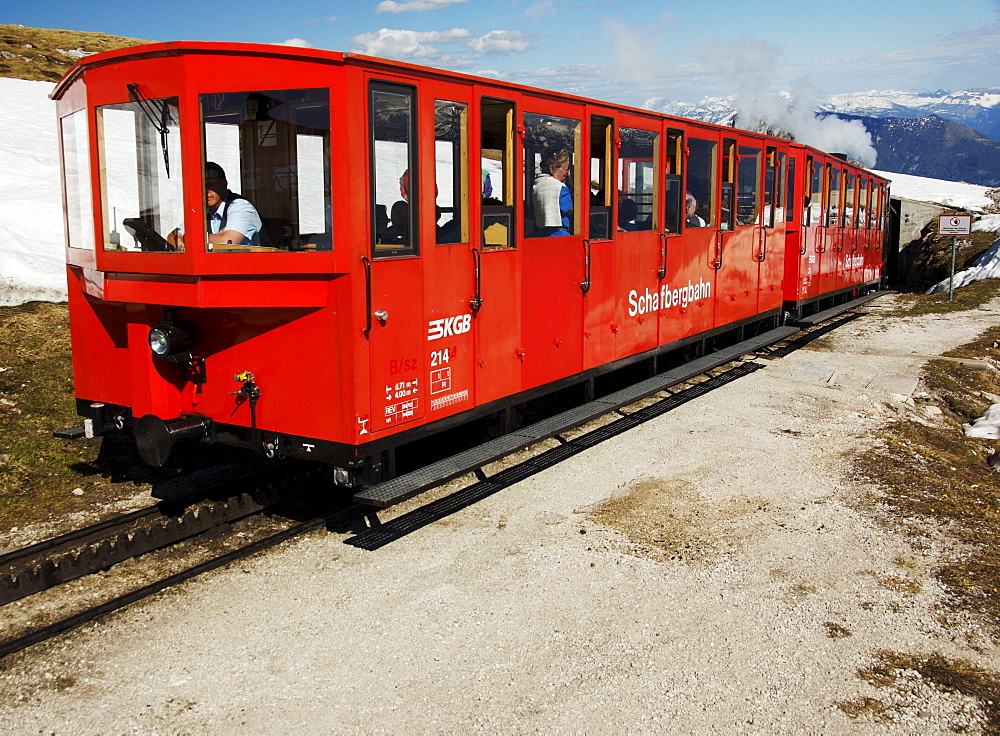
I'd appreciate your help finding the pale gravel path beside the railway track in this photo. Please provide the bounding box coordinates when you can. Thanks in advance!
[0,297,1000,734]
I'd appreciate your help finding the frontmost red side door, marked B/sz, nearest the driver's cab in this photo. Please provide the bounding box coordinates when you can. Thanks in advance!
[368,77,428,432]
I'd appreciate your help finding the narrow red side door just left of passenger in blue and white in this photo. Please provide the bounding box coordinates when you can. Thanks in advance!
[470,95,527,404]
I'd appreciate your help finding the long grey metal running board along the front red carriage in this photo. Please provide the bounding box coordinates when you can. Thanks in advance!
[354,326,799,509]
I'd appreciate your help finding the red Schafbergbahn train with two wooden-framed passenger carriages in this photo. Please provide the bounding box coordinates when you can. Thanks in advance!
[53,43,886,486]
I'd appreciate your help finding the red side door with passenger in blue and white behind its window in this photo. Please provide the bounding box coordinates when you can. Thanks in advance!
[519,96,590,388]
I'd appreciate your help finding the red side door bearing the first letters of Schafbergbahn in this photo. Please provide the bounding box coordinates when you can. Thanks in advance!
[610,115,665,358]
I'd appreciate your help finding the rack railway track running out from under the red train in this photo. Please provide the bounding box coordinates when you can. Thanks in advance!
[0,294,876,658]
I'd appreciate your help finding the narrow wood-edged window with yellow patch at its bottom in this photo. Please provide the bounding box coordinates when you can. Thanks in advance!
[479,97,515,250]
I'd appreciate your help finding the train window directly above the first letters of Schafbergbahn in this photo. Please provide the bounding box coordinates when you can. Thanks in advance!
[618,128,660,232]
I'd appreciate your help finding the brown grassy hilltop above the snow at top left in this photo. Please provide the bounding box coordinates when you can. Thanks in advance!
[0,25,149,82]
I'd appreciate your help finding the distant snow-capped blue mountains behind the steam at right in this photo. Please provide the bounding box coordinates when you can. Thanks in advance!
[644,89,1000,187]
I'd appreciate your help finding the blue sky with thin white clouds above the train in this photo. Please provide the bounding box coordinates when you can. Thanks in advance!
[7,0,1000,105]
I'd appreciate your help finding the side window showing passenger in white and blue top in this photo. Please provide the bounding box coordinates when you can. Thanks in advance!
[524,112,581,238]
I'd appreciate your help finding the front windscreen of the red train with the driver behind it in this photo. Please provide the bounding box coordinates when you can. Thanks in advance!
[199,89,333,253]
